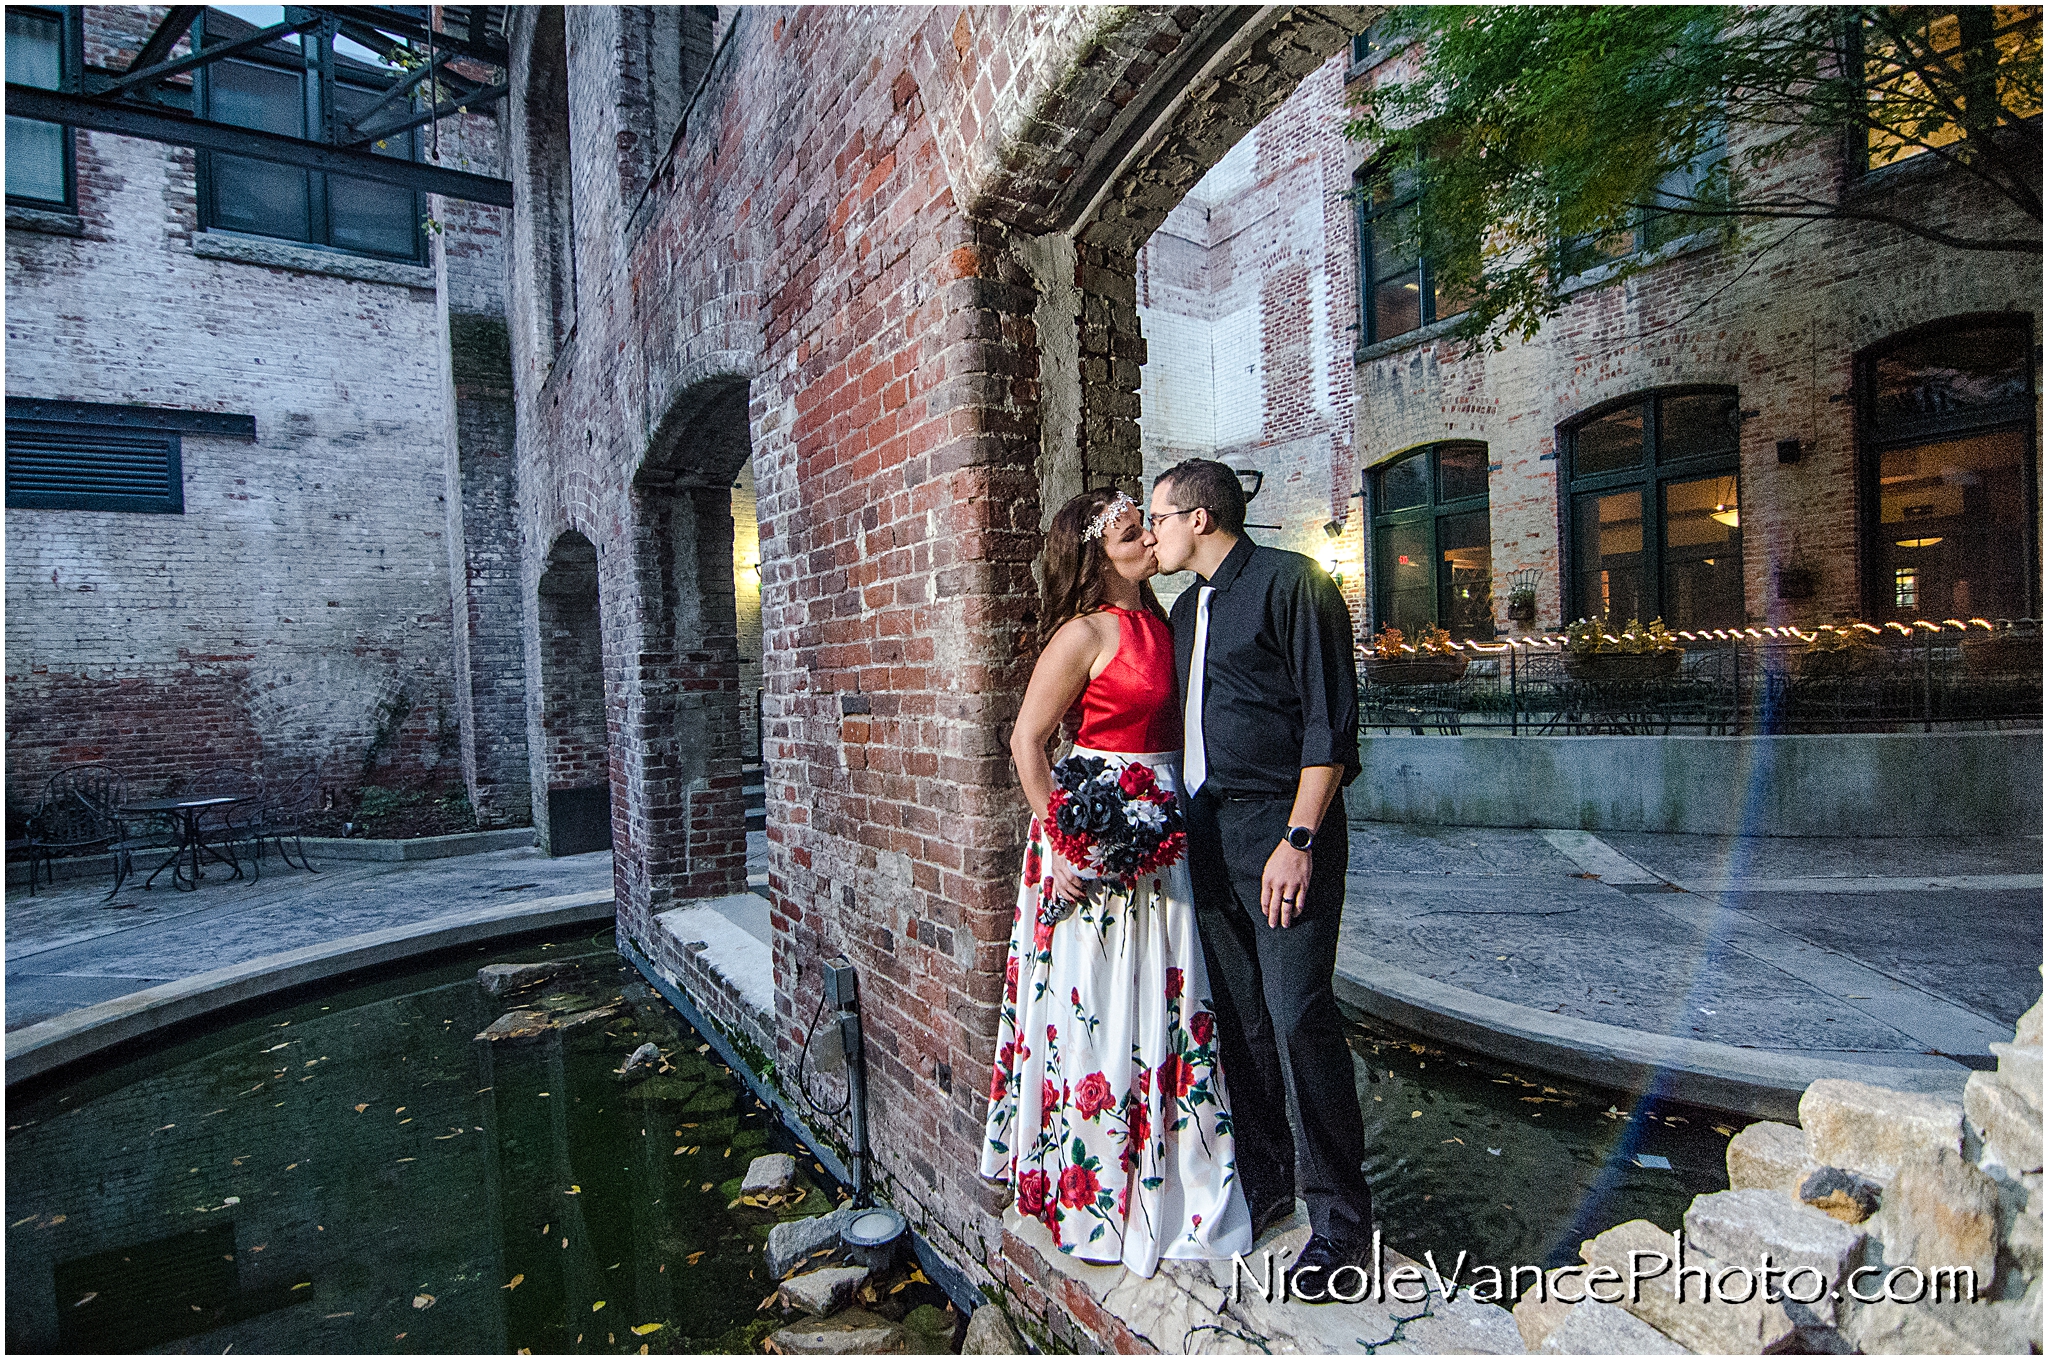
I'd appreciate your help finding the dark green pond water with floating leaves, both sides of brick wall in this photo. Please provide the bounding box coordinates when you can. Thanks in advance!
[6,932,1737,1354]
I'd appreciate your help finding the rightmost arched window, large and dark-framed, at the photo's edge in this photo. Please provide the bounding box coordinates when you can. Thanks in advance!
[1858,317,2040,623]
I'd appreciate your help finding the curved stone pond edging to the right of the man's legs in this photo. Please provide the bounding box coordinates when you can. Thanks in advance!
[1335,961,1970,1118]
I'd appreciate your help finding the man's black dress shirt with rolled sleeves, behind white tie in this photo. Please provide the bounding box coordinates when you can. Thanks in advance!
[1174,539,1358,797]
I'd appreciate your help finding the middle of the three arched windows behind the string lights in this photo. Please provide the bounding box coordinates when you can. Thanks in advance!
[1559,387,1743,629]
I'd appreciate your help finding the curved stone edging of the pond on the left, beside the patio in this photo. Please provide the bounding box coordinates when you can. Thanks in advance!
[6,889,612,1088]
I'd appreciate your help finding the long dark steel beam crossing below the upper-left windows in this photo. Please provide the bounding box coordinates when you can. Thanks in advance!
[6,84,512,207]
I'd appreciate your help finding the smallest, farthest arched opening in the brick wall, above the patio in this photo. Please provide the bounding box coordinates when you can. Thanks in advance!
[528,528,612,854]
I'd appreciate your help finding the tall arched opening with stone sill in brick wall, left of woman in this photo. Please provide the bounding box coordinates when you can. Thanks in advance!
[618,375,752,928]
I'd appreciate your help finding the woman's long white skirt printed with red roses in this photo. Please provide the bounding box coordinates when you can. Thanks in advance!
[981,750,1251,1276]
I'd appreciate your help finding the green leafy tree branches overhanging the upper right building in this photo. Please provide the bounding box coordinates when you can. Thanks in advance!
[1348,6,2042,348]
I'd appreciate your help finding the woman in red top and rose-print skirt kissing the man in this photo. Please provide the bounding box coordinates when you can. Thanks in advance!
[981,490,1251,1276]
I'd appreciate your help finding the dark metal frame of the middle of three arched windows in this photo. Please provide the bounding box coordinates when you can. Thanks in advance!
[1556,383,1749,619]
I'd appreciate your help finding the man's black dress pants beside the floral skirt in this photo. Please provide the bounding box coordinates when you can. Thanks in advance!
[1188,787,1372,1243]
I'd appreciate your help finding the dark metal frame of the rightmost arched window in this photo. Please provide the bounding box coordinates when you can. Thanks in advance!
[1853,311,2042,619]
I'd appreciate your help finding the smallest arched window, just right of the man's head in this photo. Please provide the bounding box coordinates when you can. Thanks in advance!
[1366,440,1493,641]
